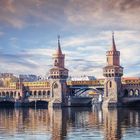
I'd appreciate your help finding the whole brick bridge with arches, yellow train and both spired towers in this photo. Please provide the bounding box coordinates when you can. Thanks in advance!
[0,34,140,106]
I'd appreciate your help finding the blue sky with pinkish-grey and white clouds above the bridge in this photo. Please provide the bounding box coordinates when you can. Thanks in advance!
[0,0,140,77]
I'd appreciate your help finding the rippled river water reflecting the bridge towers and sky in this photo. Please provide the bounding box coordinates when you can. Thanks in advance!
[0,106,140,140]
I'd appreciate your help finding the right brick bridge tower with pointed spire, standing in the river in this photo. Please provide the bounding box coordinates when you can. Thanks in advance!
[103,33,123,107]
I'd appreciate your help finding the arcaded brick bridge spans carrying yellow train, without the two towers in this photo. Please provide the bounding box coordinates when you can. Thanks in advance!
[0,78,140,106]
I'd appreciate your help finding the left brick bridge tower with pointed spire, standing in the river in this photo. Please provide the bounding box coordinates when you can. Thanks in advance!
[49,36,68,107]
